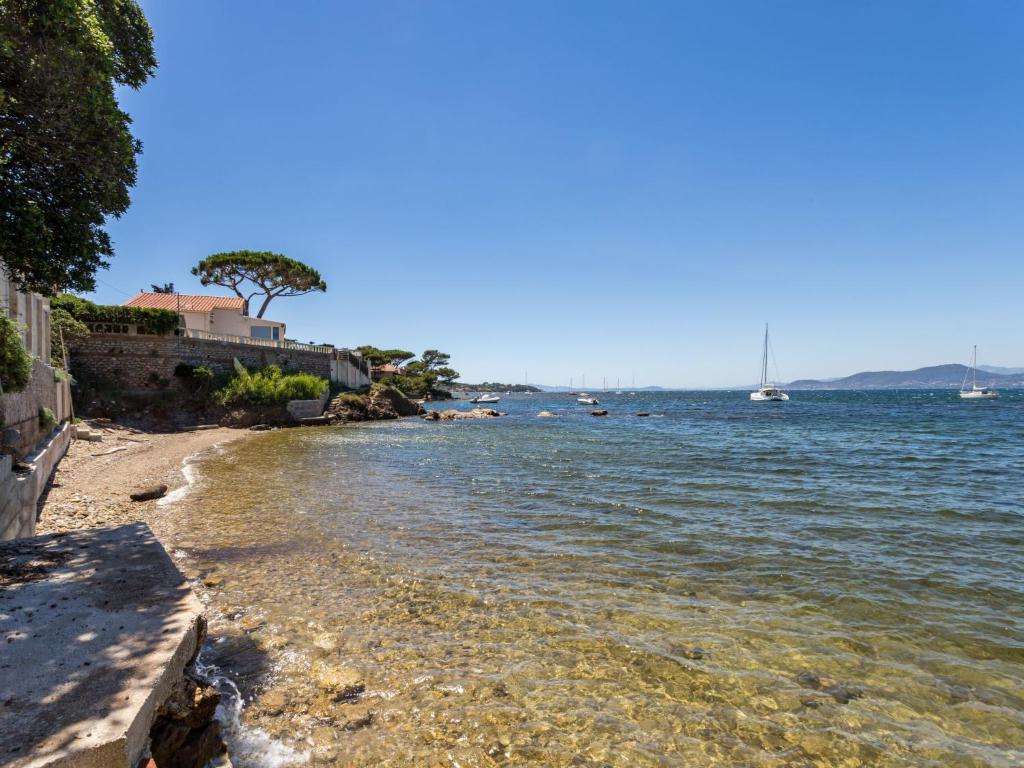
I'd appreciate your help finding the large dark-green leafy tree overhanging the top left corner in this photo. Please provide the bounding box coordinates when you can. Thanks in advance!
[0,0,157,295]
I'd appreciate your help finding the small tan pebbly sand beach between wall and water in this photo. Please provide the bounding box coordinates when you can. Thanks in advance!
[36,420,254,536]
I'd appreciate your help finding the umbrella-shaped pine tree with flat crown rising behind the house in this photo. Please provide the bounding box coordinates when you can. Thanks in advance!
[191,251,327,317]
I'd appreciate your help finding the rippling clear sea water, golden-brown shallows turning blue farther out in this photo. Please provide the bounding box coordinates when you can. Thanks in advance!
[162,392,1024,766]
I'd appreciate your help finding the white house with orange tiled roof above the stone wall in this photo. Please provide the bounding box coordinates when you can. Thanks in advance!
[125,292,286,341]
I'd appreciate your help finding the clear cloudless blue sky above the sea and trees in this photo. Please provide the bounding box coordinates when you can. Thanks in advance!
[93,0,1024,386]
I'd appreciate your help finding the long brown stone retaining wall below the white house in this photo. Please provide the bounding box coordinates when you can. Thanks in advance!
[71,334,331,391]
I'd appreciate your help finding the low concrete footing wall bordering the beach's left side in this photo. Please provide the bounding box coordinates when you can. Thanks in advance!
[0,424,71,540]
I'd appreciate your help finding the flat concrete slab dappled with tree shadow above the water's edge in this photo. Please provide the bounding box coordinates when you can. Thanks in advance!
[0,523,204,768]
